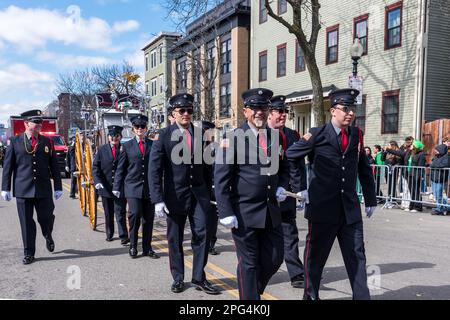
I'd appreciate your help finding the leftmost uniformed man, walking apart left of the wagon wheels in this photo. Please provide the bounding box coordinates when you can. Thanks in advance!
[1,110,62,264]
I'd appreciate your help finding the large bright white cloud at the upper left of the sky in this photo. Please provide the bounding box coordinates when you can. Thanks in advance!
[0,5,137,52]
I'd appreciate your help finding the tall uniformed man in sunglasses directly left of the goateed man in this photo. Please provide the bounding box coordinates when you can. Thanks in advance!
[149,94,220,294]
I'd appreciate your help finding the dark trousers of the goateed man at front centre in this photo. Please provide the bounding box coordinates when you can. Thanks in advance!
[232,213,284,300]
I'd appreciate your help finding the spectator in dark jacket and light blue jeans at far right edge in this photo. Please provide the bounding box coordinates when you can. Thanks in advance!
[430,144,450,216]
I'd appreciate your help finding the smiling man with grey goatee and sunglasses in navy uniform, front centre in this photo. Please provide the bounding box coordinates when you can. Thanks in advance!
[214,88,289,300]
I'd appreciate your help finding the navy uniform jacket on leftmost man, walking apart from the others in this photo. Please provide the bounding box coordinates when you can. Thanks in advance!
[2,134,62,198]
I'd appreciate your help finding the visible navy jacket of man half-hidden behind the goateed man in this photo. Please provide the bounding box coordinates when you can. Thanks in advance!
[280,127,307,213]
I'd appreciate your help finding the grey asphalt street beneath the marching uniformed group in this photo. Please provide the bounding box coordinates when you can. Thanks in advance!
[0,174,450,300]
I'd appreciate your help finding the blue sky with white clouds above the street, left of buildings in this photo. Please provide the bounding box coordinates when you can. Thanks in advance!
[0,0,174,124]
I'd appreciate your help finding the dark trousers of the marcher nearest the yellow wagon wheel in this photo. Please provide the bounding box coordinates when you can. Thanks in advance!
[102,197,128,239]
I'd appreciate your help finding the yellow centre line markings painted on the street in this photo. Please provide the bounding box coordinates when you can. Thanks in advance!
[63,183,278,300]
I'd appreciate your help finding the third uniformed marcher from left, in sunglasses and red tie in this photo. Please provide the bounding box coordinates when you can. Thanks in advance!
[112,115,159,259]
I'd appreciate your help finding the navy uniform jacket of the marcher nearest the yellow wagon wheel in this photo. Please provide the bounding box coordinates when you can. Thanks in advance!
[92,143,125,198]
